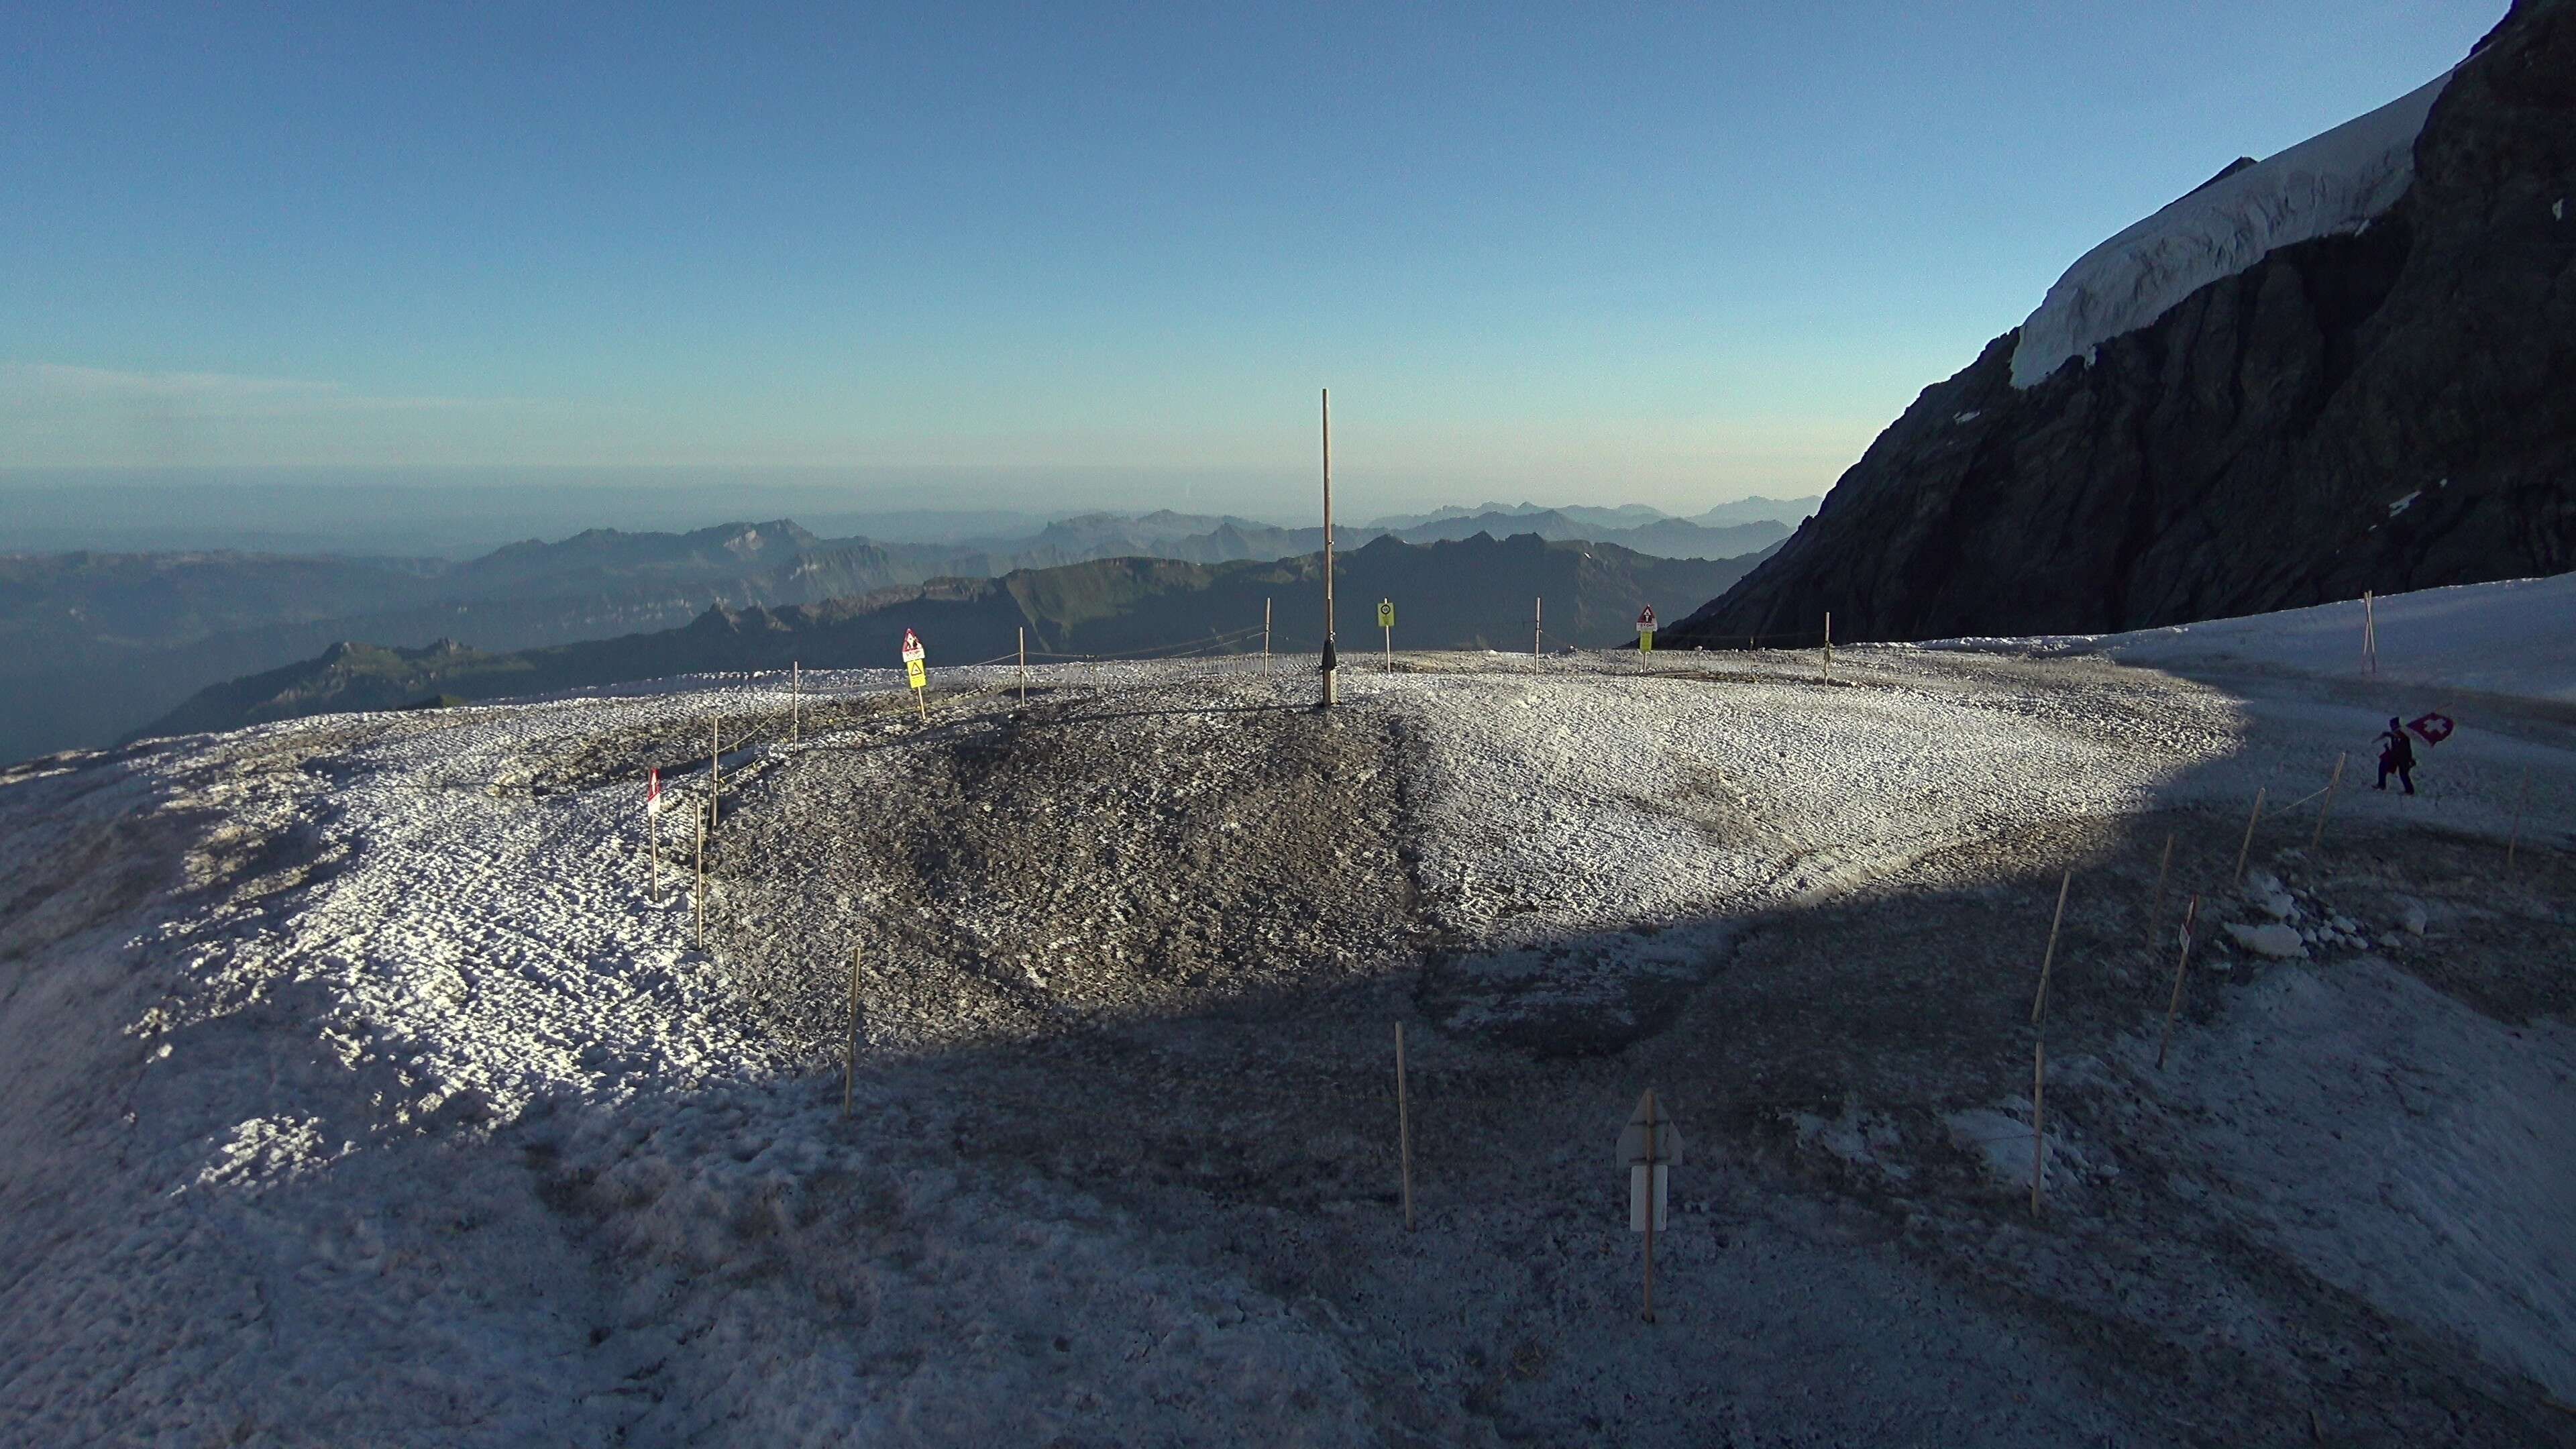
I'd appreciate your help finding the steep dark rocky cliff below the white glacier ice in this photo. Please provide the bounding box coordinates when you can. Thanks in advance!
[1672,0,2576,647]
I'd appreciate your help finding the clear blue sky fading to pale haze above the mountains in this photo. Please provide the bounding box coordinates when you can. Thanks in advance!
[0,0,2504,508]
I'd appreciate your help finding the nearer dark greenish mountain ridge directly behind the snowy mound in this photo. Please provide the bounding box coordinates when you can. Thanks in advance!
[144,534,1757,735]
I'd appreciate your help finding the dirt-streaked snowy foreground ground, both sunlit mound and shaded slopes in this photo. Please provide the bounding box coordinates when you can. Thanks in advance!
[15,580,2576,1444]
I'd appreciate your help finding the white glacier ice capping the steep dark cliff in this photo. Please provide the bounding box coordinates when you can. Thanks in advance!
[2012,72,2453,387]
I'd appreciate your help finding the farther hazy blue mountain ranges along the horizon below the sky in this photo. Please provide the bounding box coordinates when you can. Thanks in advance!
[0,502,1788,761]
